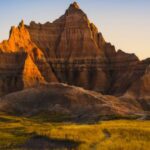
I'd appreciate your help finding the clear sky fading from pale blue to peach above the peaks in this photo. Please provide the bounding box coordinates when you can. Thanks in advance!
[0,0,150,59]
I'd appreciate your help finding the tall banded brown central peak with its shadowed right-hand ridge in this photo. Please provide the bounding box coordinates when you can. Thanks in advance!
[27,3,150,95]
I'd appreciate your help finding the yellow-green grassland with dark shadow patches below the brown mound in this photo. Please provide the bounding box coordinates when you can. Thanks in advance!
[0,113,150,150]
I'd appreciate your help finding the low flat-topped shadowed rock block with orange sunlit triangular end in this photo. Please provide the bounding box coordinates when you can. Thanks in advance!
[0,52,45,95]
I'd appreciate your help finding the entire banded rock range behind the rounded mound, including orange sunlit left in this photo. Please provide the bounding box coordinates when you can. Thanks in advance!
[0,2,150,113]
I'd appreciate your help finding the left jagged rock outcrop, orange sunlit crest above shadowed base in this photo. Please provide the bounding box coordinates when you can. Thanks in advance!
[0,21,57,95]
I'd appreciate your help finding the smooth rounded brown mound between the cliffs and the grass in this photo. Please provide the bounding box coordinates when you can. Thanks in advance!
[0,84,141,121]
